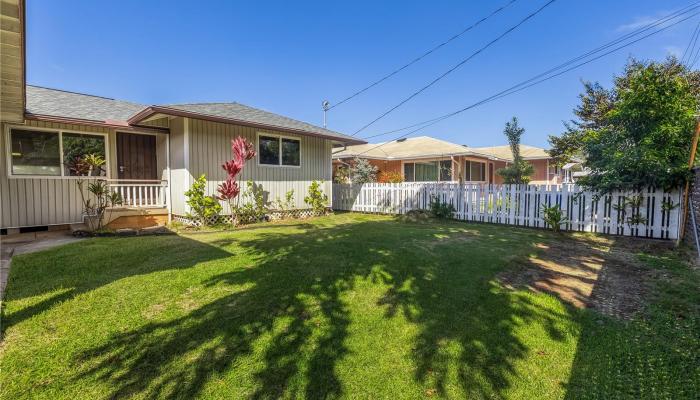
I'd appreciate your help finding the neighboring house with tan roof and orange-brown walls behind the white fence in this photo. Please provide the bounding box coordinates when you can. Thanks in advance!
[333,136,562,184]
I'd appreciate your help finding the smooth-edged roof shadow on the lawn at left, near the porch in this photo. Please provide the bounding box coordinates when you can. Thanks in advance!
[1,235,231,337]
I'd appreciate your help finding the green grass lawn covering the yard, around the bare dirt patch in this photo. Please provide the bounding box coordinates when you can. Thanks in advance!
[0,214,700,400]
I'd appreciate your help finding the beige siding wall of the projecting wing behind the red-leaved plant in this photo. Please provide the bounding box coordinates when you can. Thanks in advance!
[171,119,332,214]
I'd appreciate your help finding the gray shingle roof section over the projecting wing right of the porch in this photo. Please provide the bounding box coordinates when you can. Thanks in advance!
[164,103,358,141]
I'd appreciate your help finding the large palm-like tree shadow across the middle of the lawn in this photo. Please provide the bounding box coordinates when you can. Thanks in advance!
[71,221,565,399]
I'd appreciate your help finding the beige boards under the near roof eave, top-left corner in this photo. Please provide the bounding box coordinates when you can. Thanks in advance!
[0,0,24,122]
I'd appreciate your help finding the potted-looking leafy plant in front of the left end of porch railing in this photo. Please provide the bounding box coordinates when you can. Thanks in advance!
[77,179,123,232]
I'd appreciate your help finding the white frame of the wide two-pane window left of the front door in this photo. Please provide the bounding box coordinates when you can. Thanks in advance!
[5,125,112,179]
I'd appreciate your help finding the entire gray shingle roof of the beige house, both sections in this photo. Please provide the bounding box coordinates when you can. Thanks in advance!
[26,85,358,142]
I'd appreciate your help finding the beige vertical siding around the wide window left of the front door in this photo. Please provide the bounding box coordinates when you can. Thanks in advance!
[0,120,165,228]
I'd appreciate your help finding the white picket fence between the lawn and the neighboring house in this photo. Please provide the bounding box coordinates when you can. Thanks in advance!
[333,183,681,239]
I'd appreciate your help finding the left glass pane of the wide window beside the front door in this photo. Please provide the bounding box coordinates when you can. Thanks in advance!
[10,129,61,176]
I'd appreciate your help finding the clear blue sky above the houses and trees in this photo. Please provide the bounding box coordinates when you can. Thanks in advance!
[27,0,700,146]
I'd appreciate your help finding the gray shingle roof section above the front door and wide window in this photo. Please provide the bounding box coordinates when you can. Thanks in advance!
[27,85,146,122]
